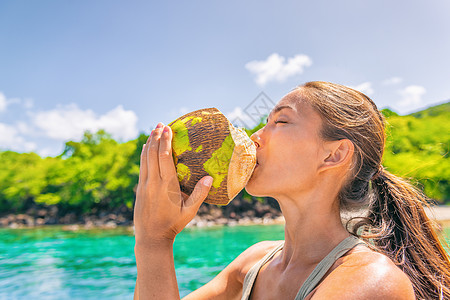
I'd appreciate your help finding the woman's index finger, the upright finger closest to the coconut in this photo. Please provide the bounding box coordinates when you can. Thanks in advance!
[159,126,178,183]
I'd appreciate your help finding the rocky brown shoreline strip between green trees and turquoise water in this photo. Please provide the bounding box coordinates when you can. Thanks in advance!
[0,206,450,231]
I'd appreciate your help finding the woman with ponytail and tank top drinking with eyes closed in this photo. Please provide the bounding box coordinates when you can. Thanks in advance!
[134,82,450,300]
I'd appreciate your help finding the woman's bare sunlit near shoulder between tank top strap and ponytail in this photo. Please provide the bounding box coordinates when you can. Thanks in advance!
[310,246,415,299]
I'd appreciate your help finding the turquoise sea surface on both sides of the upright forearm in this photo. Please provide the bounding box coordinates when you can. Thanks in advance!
[0,225,450,300]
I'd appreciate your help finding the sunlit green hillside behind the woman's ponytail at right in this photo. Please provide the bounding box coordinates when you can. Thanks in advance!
[383,102,450,202]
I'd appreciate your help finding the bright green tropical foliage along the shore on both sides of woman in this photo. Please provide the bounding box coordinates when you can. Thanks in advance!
[0,103,450,214]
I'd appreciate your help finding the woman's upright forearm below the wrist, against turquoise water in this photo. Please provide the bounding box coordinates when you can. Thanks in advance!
[134,241,180,300]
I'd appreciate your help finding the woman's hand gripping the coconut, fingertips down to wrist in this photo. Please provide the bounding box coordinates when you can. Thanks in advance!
[134,123,212,244]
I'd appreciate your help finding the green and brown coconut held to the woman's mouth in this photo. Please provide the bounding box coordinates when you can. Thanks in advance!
[169,108,256,205]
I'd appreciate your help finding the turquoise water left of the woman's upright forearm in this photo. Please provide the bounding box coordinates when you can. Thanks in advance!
[0,227,136,299]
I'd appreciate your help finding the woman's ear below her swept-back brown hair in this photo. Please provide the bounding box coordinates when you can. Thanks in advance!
[320,139,355,170]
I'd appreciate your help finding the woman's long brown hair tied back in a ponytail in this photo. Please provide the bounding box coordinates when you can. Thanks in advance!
[298,82,450,299]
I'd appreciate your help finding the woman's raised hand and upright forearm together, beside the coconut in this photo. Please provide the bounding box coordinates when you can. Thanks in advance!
[134,122,211,300]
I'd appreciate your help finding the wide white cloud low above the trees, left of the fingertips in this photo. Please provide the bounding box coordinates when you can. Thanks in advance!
[30,104,138,141]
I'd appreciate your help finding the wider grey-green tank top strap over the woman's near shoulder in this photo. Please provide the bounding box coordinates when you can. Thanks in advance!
[295,235,365,300]
